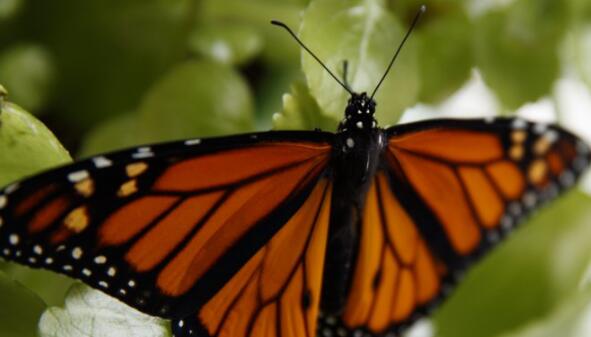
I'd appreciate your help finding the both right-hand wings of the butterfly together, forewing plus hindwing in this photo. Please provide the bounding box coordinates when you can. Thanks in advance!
[320,119,591,337]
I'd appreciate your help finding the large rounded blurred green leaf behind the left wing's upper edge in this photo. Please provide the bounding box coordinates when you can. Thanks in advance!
[139,61,254,142]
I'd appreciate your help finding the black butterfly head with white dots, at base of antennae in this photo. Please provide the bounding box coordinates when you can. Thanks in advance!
[339,92,377,131]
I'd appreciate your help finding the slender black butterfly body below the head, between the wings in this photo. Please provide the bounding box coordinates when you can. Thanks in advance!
[322,128,384,314]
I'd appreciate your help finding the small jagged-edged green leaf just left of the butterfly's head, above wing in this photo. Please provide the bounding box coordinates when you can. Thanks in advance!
[273,82,338,131]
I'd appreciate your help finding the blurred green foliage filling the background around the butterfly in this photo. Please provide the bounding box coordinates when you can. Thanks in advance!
[0,0,591,337]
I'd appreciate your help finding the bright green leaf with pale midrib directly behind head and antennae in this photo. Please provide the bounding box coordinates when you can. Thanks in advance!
[300,0,419,125]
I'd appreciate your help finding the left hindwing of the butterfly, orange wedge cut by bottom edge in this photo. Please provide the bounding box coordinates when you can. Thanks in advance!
[173,179,332,337]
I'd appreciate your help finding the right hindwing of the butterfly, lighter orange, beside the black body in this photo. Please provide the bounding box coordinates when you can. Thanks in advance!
[332,172,446,333]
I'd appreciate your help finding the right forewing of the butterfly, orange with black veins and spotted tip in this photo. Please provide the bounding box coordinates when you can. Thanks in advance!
[386,119,589,257]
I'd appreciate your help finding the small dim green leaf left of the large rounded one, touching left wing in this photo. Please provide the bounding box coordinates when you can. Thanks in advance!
[78,113,140,158]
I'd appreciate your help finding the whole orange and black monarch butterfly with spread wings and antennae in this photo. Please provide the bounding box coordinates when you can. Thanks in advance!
[0,4,591,337]
